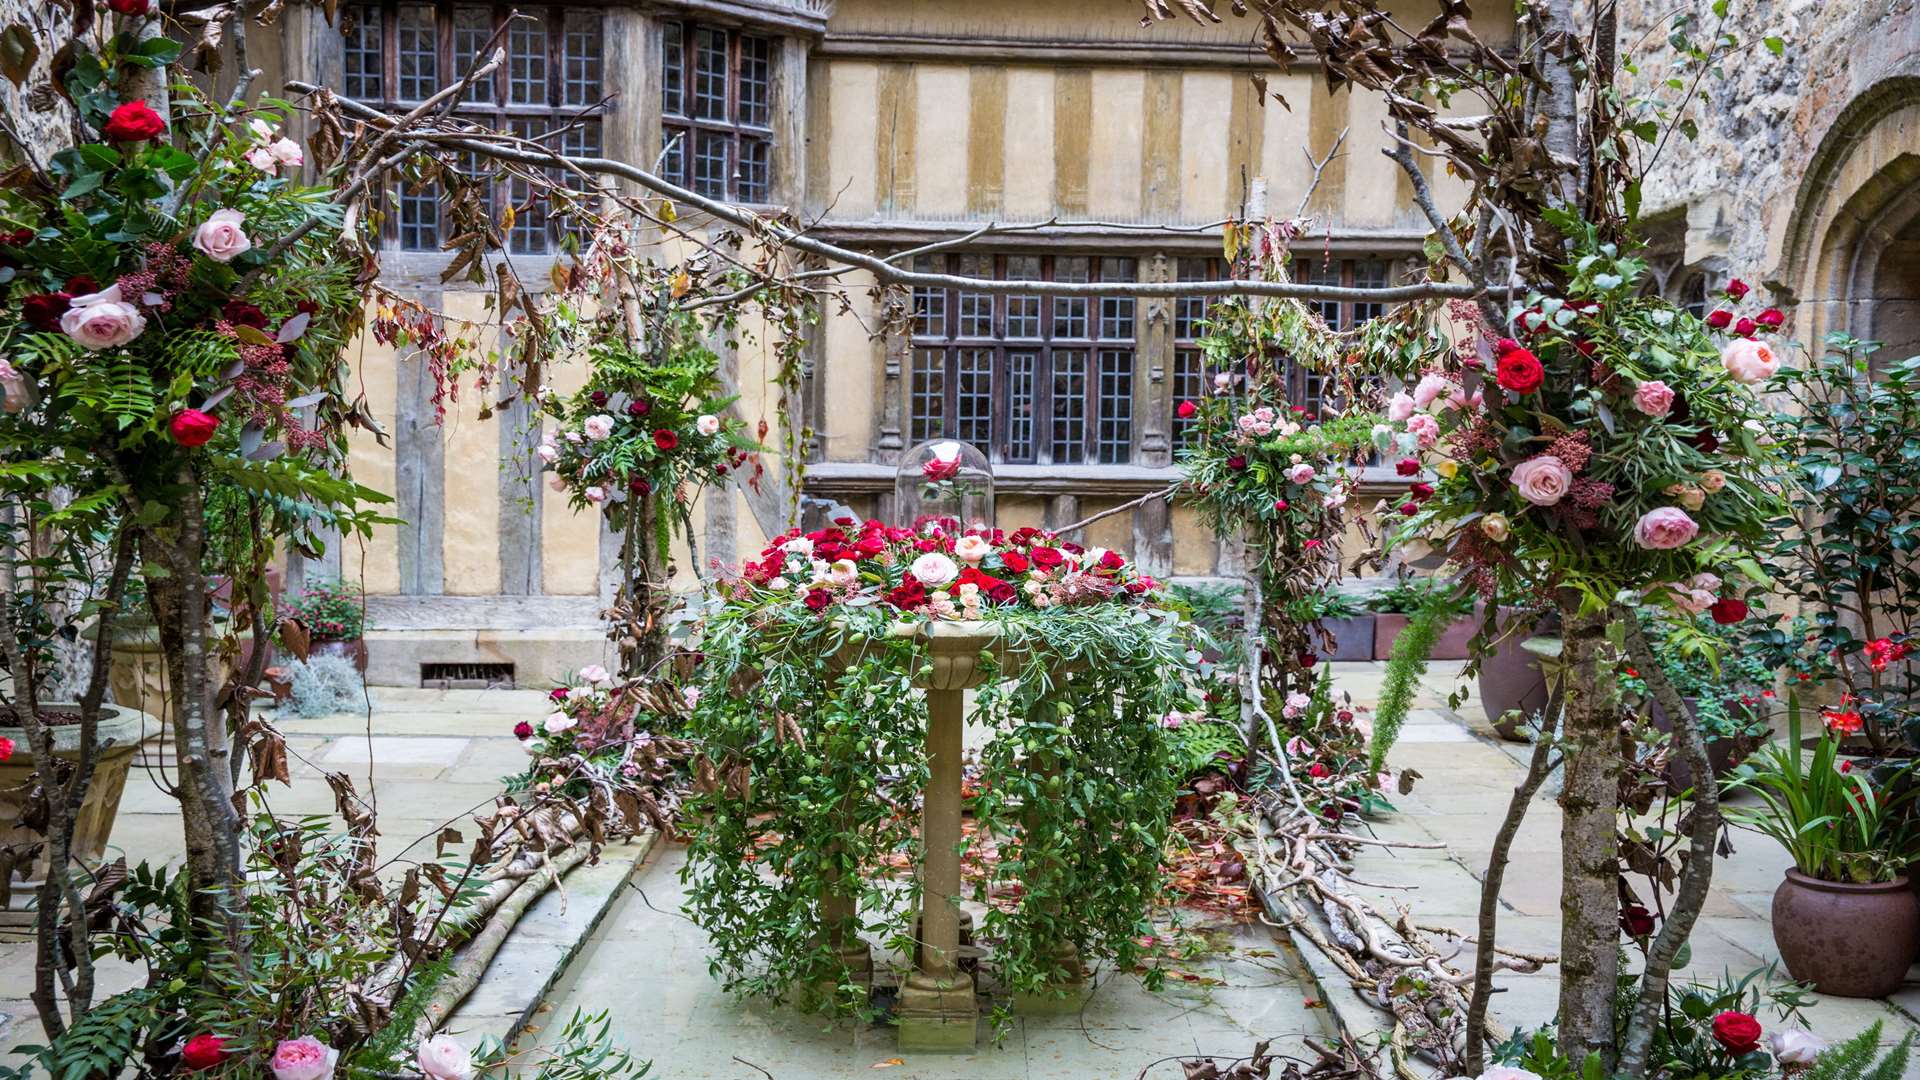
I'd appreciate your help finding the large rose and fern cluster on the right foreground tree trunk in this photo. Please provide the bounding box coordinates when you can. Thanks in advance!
[1388,231,1782,607]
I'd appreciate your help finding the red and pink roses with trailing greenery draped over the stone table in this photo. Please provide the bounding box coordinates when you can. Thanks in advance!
[685,519,1212,1011]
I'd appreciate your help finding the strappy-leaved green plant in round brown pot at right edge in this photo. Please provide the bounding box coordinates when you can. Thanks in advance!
[1726,700,1920,997]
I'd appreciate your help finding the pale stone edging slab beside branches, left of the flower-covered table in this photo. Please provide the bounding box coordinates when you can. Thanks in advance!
[440,832,659,1049]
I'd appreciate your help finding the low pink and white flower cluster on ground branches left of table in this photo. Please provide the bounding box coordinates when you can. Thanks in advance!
[507,663,699,832]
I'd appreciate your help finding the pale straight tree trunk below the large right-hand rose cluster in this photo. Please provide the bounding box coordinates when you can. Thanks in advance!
[1559,598,1620,1067]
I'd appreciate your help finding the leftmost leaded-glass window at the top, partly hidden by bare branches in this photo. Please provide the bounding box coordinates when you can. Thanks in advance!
[340,0,616,261]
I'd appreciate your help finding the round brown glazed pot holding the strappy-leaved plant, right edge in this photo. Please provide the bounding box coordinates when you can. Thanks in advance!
[1774,871,1920,997]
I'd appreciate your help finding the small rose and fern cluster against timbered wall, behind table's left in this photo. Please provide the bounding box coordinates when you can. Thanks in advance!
[536,313,760,534]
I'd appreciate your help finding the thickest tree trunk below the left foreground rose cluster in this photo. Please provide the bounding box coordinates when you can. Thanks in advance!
[140,474,247,963]
